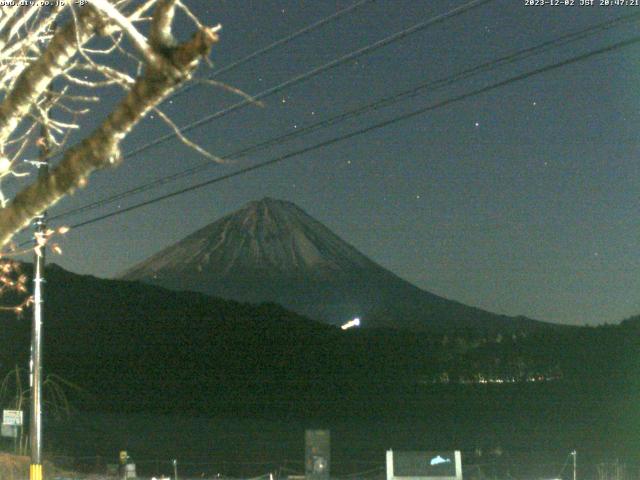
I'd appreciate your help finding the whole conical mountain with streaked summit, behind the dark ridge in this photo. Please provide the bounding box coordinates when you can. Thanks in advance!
[121,198,542,331]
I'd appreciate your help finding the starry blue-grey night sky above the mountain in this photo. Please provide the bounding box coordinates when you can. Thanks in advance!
[13,0,640,324]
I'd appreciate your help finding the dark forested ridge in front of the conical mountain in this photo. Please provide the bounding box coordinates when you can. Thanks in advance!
[0,265,640,468]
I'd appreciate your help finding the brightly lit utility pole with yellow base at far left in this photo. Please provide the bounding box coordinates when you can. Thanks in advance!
[29,112,49,480]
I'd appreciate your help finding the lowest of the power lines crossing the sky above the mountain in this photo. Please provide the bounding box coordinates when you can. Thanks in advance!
[62,36,640,232]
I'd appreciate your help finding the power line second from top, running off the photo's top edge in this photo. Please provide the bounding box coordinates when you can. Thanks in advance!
[124,0,494,158]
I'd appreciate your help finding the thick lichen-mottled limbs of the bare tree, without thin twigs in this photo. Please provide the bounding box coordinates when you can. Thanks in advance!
[0,0,220,247]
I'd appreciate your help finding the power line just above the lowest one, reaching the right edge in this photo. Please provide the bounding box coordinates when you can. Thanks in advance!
[51,13,640,219]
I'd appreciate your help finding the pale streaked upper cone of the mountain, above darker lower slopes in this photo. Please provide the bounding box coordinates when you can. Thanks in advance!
[123,197,375,279]
